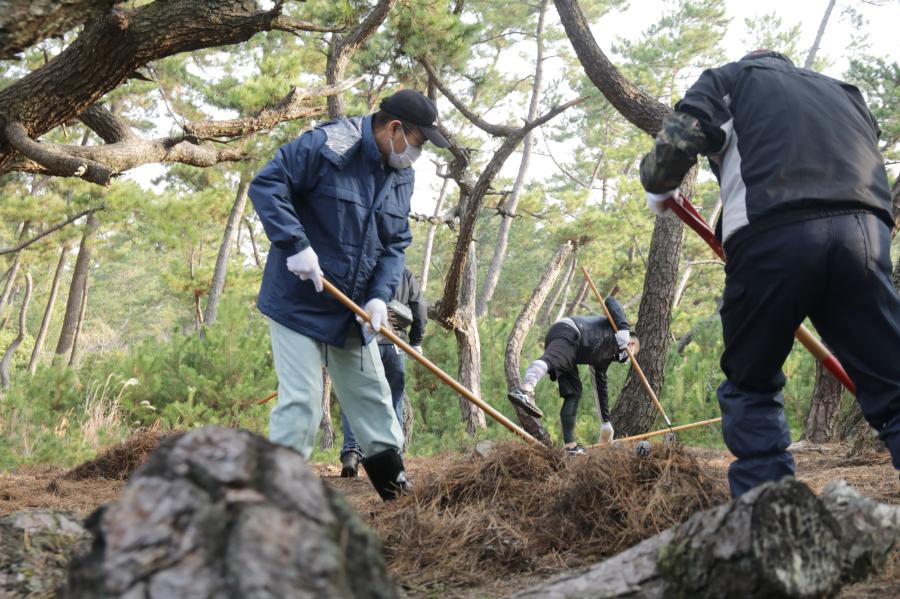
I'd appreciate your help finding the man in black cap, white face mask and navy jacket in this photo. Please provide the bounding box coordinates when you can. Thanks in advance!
[249,90,448,500]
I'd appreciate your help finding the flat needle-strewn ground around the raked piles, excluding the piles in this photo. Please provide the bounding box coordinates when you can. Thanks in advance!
[0,438,900,599]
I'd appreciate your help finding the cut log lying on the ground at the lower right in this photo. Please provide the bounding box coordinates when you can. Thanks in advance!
[513,478,900,599]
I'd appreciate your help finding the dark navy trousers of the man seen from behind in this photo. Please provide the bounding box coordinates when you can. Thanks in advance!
[718,213,900,497]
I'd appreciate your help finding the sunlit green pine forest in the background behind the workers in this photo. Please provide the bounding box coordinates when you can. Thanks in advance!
[0,0,900,468]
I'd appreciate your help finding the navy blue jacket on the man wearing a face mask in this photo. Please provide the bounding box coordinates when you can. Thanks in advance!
[249,116,414,347]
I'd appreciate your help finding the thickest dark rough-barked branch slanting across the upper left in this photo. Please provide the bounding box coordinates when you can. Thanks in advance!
[0,0,342,174]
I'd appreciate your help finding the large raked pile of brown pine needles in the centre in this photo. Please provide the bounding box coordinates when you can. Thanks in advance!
[372,443,729,584]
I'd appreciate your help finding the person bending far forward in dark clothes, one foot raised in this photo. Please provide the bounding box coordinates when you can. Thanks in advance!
[509,297,640,455]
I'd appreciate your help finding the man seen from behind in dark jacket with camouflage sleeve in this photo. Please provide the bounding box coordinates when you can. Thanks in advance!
[641,50,900,496]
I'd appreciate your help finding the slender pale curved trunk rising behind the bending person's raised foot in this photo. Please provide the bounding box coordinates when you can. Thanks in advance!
[503,241,574,445]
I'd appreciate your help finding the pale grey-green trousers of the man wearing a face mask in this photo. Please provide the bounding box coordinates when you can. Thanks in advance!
[269,319,403,459]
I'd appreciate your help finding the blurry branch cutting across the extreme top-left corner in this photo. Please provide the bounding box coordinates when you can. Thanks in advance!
[0,0,120,60]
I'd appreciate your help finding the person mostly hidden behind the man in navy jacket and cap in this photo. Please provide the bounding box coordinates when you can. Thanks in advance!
[341,268,428,478]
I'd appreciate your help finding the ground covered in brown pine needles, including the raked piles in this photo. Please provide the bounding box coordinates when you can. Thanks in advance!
[0,432,900,598]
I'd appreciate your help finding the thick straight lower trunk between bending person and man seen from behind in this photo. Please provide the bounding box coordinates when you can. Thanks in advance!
[610,167,697,437]
